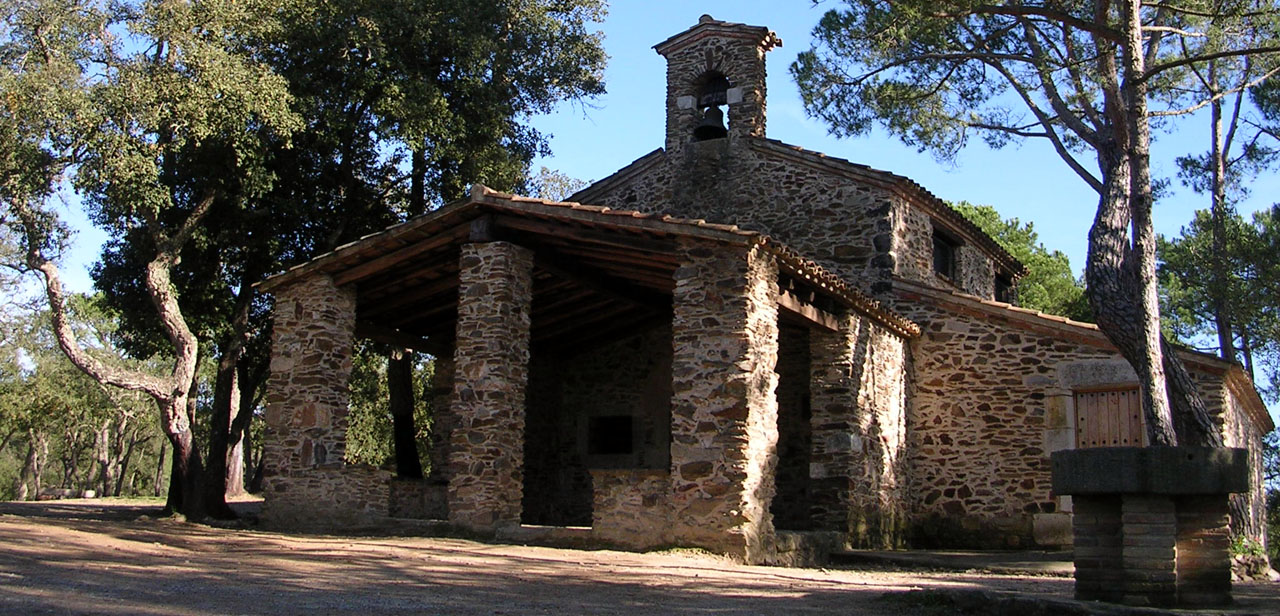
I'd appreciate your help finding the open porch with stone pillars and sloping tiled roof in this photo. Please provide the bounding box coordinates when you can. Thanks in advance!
[264,186,918,562]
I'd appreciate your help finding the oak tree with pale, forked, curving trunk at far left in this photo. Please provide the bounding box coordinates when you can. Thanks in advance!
[0,0,298,516]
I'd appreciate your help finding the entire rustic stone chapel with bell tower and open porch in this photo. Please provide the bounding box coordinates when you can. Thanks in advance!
[262,15,1274,563]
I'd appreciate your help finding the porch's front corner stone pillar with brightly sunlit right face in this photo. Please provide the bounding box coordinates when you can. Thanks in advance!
[671,239,778,562]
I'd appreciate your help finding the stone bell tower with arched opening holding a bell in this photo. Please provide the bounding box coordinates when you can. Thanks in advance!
[653,15,782,154]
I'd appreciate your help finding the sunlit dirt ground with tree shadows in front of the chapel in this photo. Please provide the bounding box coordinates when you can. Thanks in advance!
[0,501,1269,616]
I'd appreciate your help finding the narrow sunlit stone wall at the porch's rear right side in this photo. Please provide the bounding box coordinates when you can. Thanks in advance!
[809,309,910,548]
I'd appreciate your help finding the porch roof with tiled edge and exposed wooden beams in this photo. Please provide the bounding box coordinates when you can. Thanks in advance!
[260,186,919,352]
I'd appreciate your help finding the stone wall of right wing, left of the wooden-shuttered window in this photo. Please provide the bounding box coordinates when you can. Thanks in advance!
[895,295,1115,548]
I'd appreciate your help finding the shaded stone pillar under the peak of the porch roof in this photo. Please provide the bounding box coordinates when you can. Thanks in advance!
[448,242,534,531]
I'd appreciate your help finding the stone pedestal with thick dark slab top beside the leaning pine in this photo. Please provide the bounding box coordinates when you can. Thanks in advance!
[1051,447,1249,607]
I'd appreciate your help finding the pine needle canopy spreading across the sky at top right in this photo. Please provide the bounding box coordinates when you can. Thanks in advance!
[791,0,1277,170]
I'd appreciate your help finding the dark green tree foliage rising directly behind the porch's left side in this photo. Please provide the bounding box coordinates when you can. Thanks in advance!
[93,0,604,360]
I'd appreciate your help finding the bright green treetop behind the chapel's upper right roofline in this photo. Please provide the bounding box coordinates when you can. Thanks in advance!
[951,201,1092,321]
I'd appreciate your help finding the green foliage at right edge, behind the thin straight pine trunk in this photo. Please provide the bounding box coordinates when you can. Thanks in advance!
[1158,206,1280,402]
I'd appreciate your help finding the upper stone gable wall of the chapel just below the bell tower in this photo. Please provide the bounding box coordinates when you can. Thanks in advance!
[579,140,995,298]
